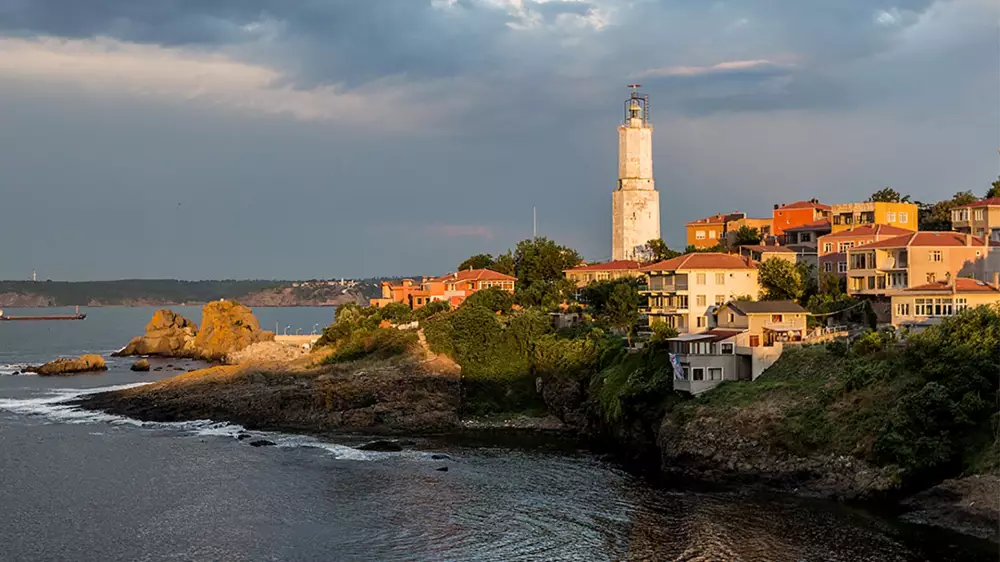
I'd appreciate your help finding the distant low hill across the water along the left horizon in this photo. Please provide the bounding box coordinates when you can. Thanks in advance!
[0,279,378,307]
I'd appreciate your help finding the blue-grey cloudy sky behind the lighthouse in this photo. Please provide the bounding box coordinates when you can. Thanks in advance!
[0,0,1000,280]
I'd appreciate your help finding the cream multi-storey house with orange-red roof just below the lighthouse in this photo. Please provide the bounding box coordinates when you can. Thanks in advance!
[642,252,760,333]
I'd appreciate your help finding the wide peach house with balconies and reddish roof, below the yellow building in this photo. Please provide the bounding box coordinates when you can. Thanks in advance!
[847,232,1000,299]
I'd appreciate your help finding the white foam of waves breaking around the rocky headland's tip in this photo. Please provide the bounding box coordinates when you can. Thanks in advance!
[0,382,396,461]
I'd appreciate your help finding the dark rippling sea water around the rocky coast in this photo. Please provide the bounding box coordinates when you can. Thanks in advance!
[0,307,997,562]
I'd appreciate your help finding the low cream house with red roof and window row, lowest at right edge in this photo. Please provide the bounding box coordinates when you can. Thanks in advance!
[891,272,1000,330]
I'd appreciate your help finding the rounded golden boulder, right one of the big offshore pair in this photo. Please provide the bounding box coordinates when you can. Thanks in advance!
[194,301,274,361]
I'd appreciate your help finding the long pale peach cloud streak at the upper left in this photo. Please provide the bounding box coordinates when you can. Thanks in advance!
[0,37,454,131]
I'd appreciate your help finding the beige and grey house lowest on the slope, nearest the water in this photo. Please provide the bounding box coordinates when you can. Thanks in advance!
[667,301,810,394]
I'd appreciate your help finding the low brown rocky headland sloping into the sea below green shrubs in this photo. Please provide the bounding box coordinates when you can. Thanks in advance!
[78,356,462,435]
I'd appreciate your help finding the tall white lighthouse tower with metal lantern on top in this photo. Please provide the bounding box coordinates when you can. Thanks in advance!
[611,84,660,260]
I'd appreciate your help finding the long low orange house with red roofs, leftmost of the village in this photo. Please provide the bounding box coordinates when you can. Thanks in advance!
[369,269,517,309]
